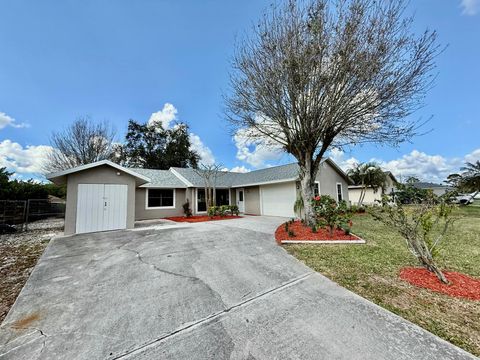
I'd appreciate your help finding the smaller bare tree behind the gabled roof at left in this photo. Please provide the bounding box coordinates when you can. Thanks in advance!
[46,117,115,171]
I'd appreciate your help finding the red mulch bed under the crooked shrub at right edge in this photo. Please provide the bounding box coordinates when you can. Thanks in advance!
[400,267,480,301]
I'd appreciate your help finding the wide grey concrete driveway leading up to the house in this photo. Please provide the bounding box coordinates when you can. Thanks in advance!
[0,217,474,360]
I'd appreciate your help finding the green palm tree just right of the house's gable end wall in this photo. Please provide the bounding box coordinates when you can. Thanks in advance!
[347,162,387,206]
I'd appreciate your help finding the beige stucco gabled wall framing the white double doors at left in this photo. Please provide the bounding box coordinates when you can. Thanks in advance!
[64,165,135,235]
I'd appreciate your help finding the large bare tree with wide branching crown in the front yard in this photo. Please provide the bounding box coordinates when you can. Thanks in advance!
[226,0,441,222]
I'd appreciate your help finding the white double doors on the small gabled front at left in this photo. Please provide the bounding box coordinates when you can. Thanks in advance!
[76,184,128,233]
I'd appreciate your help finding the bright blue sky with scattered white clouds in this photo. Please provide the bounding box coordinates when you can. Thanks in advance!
[0,0,480,181]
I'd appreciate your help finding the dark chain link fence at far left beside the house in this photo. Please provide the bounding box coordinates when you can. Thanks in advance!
[0,199,65,233]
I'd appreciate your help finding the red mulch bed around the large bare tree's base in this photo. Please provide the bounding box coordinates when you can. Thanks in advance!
[275,220,359,244]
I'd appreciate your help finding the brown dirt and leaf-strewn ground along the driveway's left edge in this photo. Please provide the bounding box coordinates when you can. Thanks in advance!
[0,219,63,323]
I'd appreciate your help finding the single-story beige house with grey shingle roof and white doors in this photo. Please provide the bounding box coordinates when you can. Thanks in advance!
[47,159,351,234]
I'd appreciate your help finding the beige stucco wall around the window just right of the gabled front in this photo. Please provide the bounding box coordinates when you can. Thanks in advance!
[135,188,191,220]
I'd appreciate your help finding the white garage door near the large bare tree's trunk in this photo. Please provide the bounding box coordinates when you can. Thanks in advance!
[260,182,297,217]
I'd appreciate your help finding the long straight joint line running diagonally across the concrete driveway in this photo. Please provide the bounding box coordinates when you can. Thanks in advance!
[111,271,315,360]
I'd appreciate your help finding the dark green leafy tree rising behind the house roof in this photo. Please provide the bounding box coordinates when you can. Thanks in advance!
[115,120,200,170]
